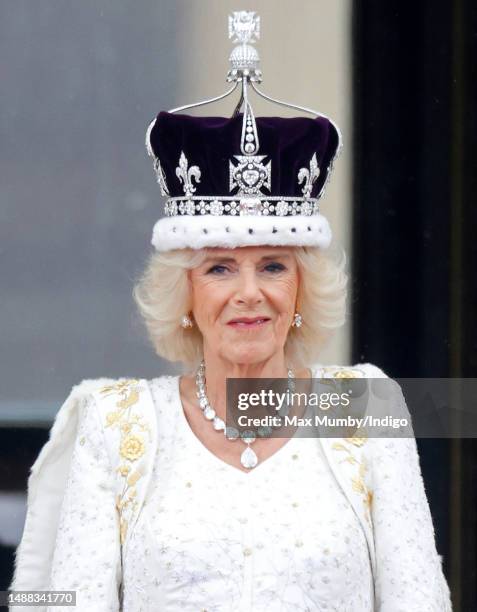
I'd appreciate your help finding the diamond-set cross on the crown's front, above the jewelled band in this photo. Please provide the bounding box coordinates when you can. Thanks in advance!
[229,155,272,195]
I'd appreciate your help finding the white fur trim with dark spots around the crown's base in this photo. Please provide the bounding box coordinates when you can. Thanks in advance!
[151,214,331,251]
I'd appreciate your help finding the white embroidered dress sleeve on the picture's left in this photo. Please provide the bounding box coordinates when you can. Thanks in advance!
[47,395,121,612]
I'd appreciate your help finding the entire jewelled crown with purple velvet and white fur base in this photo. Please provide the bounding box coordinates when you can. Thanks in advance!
[146,11,341,251]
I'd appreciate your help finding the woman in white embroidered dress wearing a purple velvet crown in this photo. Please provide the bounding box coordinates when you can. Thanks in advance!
[11,41,451,612]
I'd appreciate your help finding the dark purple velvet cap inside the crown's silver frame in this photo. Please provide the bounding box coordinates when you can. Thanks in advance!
[149,111,340,198]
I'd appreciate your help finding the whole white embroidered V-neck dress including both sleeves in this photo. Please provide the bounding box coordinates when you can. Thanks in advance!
[11,366,451,612]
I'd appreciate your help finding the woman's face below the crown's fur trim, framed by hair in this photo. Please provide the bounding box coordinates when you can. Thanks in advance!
[190,246,299,363]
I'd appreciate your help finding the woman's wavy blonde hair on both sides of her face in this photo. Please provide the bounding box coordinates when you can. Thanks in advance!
[133,247,348,368]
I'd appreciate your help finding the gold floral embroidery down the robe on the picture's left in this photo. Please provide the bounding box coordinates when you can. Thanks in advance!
[100,379,150,545]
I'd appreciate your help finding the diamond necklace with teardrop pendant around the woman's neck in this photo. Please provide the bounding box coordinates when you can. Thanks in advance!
[195,360,295,469]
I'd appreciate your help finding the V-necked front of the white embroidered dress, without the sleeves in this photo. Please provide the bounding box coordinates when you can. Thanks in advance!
[119,379,374,612]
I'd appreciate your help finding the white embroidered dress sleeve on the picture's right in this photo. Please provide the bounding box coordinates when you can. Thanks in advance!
[369,385,452,612]
